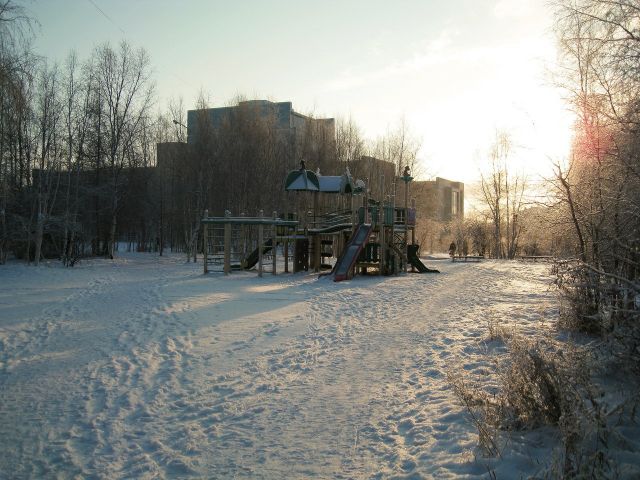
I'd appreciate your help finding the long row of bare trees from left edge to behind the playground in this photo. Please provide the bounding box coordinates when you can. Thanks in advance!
[0,0,428,265]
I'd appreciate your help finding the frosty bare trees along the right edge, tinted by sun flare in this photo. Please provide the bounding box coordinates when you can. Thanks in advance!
[550,0,640,373]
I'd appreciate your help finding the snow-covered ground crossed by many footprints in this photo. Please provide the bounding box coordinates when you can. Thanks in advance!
[0,254,568,479]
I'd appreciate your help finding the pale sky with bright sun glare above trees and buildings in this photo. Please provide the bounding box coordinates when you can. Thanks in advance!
[25,0,572,189]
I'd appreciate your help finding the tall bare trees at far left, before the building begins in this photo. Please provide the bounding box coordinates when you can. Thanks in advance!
[0,1,155,264]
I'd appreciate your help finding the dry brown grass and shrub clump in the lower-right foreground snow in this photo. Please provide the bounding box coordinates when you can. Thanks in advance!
[448,332,613,478]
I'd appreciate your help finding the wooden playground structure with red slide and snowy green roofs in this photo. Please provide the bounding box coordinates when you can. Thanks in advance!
[202,166,437,282]
